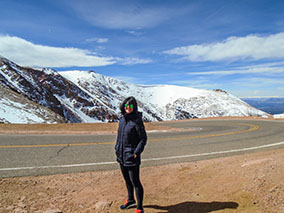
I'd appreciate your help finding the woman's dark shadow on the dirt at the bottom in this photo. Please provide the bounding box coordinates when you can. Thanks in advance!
[144,202,239,213]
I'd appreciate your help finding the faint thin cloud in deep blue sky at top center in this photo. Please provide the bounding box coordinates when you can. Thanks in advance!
[68,0,177,29]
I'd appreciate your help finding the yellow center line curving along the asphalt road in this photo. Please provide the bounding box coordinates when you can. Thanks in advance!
[0,123,259,148]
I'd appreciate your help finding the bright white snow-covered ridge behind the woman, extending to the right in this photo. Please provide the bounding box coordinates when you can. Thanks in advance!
[60,71,270,121]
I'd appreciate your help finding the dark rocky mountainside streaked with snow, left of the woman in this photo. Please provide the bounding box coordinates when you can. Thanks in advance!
[0,58,117,123]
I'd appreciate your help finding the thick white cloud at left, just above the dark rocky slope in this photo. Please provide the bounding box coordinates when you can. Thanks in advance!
[0,35,116,67]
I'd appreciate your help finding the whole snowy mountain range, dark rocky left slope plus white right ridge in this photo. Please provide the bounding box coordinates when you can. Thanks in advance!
[0,57,268,122]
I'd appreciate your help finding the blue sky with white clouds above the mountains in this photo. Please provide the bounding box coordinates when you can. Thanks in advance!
[0,0,284,97]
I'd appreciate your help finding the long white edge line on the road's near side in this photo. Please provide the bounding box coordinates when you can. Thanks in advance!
[0,141,284,171]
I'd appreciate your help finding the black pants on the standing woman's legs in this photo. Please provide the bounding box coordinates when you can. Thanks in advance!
[120,164,144,209]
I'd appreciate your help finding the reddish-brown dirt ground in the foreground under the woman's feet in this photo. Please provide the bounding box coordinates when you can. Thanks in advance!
[0,117,284,213]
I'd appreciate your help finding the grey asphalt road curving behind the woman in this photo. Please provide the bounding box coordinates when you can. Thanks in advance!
[0,120,284,178]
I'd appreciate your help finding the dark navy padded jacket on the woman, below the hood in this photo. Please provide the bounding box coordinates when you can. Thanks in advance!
[115,112,147,166]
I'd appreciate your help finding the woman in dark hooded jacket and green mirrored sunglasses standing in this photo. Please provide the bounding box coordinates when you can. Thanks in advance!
[115,96,147,213]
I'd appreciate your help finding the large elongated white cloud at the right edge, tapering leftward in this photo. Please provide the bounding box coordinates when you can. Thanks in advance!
[164,33,284,61]
